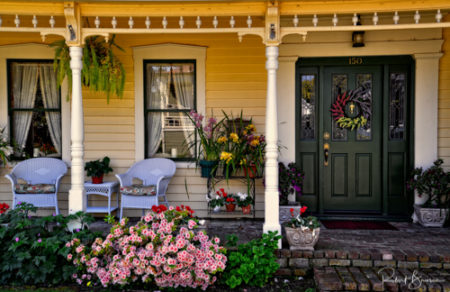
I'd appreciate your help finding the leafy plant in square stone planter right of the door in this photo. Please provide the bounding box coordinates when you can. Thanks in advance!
[407,159,450,227]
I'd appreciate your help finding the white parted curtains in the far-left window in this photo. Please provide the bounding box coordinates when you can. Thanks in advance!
[12,63,61,154]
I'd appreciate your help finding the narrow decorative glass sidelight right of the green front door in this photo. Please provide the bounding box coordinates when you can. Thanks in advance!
[389,73,406,140]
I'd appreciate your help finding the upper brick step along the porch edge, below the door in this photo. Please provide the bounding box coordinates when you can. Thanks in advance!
[277,249,450,275]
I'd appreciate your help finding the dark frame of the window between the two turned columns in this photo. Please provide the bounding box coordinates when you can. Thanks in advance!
[143,59,198,162]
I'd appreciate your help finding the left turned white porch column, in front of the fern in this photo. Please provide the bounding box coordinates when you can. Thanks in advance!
[69,47,86,213]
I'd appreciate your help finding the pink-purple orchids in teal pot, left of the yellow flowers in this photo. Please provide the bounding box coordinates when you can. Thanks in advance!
[188,110,223,178]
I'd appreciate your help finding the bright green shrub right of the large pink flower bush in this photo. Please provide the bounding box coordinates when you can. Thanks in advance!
[221,231,281,289]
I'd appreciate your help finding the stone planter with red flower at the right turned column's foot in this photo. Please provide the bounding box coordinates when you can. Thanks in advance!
[283,206,320,250]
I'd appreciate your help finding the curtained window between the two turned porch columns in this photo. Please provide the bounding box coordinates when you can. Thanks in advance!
[144,60,196,160]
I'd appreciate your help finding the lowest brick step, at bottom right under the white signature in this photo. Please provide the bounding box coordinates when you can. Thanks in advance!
[314,267,450,292]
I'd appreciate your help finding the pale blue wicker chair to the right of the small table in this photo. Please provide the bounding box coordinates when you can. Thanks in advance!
[116,158,176,219]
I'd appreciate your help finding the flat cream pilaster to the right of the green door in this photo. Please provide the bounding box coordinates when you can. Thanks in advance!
[414,53,442,204]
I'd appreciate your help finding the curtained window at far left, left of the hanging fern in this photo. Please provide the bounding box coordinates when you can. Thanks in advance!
[8,60,62,159]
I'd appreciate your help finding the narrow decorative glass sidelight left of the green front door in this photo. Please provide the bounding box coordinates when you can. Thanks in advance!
[301,74,316,140]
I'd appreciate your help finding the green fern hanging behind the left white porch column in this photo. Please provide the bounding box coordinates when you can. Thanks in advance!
[50,35,125,102]
